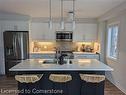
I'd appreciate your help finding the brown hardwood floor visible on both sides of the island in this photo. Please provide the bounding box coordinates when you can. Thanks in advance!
[0,76,126,95]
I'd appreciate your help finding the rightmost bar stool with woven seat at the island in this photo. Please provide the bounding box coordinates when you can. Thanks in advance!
[80,74,105,95]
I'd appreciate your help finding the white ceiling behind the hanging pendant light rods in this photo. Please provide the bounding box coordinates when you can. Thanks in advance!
[0,0,126,18]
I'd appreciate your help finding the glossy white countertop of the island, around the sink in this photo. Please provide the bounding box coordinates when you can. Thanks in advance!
[9,59,113,71]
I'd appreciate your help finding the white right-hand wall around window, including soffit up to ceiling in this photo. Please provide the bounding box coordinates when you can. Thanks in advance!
[98,2,126,93]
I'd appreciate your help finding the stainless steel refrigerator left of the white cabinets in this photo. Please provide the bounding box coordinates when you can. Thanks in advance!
[3,31,29,76]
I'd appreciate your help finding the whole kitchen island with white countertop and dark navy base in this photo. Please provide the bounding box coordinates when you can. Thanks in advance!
[10,59,113,95]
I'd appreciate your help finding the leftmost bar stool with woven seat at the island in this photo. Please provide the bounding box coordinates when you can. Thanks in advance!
[15,74,43,95]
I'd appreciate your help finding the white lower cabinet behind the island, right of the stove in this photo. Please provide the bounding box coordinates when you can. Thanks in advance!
[74,54,100,60]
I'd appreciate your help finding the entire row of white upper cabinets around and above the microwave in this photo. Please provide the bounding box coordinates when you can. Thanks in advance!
[30,22,97,42]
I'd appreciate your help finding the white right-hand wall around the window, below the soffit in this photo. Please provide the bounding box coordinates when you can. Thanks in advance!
[106,13,126,93]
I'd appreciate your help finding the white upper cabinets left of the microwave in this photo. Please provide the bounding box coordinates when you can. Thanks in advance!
[30,22,55,41]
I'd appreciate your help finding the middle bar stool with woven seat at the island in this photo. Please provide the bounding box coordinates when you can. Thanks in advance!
[49,74,72,95]
